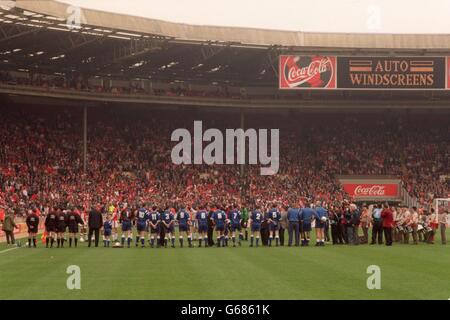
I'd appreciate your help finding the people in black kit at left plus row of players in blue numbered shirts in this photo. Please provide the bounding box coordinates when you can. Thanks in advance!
[26,203,281,248]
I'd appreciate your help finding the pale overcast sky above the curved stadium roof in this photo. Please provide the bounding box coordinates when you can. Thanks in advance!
[59,0,450,33]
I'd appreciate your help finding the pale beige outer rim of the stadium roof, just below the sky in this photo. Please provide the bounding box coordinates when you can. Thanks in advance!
[11,0,450,49]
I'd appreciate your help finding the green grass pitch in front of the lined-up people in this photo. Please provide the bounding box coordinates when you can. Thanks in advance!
[0,231,450,300]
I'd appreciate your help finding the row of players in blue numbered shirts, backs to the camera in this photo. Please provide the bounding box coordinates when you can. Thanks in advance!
[103,204,281,248]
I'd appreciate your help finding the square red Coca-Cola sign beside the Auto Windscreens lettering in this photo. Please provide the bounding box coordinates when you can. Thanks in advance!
[279,55,336,89]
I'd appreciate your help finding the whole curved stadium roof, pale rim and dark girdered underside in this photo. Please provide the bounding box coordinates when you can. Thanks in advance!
[0,0,450,106]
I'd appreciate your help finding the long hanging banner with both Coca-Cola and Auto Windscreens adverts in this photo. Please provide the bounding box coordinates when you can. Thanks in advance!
[279,55,450,90]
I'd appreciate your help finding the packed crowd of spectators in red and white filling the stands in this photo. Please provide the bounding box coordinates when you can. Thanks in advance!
[0,106,450,219]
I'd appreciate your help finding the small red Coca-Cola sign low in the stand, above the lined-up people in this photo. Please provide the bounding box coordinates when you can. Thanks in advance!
[343,183,399,198]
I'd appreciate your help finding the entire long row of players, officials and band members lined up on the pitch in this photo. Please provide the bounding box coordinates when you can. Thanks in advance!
[21,202,448,247]
